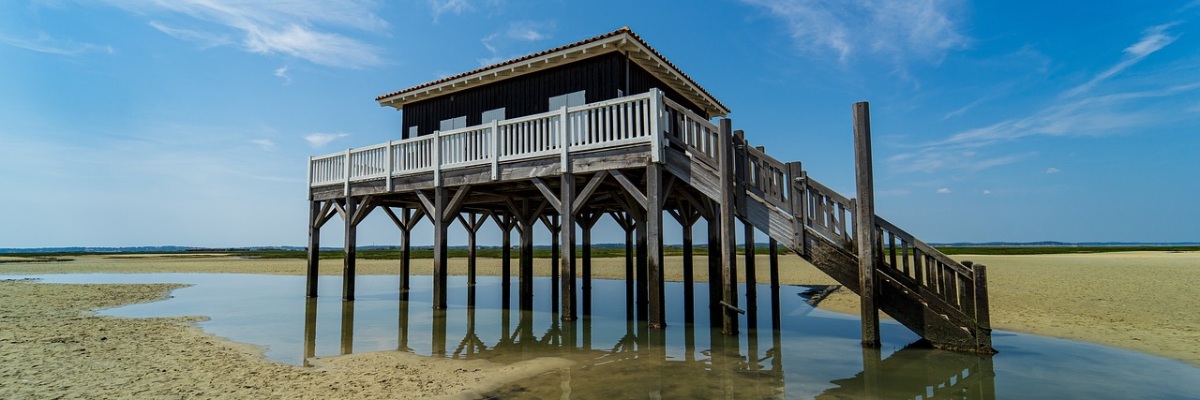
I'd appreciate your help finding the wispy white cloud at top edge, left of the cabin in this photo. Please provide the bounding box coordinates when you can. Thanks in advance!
[109,0,388,67]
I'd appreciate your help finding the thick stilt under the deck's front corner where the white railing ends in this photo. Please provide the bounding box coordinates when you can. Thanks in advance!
[646,164,667,329]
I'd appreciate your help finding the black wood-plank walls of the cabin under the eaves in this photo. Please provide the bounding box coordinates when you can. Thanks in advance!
[402,53,707,138]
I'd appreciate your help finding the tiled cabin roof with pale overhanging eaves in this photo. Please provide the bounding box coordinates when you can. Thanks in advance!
[376,26,730,117]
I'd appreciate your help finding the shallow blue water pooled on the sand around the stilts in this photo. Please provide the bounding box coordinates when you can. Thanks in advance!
[4,274,1200,399]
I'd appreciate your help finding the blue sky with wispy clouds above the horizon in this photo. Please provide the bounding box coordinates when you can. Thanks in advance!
[0,0,1200,247]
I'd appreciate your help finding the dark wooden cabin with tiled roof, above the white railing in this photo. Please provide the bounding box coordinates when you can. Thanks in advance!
[376,29,730,138]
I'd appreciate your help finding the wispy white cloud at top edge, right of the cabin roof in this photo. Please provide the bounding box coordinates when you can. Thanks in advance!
[742,0,970,64]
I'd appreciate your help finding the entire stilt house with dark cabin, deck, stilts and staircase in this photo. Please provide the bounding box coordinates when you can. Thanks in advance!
[307,28,991,352]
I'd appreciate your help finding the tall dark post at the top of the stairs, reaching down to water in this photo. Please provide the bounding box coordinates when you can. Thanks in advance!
[718,118,739,335]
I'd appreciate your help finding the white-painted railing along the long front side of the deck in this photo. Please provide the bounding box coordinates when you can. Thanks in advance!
[308,90,662,192]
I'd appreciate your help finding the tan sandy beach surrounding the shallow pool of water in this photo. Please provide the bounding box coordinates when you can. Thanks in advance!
[0,252,1200,399]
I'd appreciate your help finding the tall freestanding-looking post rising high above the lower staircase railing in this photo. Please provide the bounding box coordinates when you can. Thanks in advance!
[854,102,880,347]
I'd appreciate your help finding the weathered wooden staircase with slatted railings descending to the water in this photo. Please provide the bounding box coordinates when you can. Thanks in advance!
[662,100,992,353]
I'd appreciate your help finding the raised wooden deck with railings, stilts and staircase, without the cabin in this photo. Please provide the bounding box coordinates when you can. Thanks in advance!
[308,90,992,353]
